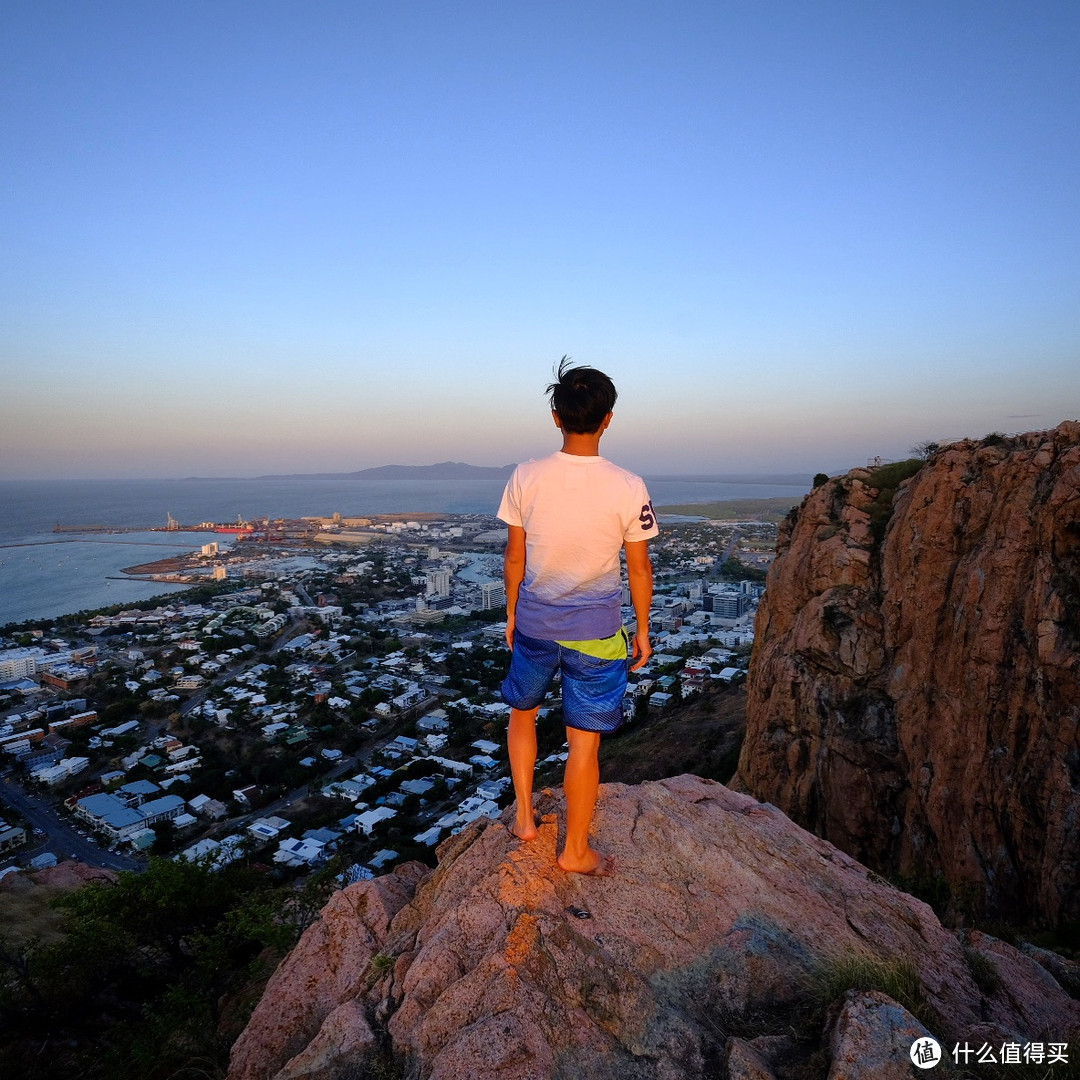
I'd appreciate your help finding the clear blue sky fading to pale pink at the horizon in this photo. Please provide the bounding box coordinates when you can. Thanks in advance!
[0,0,1080,478]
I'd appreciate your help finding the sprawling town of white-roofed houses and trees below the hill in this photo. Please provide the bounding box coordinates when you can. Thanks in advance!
[0,515,775,880]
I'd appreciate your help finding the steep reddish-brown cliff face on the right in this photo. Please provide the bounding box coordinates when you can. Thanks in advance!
[739,422,1080,920]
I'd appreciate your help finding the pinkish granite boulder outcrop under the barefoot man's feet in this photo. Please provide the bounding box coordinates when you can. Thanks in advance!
[230,777,1080,1080]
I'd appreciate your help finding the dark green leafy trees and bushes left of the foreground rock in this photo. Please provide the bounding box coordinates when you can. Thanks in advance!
[0,859,302,1080]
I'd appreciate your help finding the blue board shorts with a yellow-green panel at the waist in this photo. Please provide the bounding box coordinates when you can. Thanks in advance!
[501,630,630,734]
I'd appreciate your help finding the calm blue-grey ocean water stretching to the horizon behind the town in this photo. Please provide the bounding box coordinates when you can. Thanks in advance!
[0,476,809,625]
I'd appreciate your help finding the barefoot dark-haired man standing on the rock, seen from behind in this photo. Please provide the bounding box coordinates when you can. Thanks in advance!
[499,356,659,875]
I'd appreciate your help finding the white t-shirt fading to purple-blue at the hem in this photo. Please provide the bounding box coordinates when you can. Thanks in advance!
[499,450,660,642]
